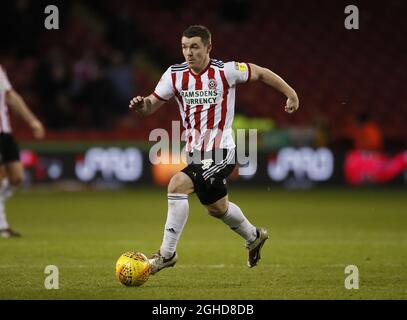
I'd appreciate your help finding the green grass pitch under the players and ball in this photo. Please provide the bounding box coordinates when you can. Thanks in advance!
[0,188,407,300]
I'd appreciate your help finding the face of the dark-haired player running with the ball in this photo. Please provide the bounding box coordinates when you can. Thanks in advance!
[181,37,211,72]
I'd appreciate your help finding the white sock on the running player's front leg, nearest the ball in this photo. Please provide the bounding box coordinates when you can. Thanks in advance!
[160,193,189,258]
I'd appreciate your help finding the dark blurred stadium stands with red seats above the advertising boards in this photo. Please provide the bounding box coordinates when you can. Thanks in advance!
[0,0,407,185]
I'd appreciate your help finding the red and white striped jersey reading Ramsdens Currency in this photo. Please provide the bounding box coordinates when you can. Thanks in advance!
[153,59,251,152]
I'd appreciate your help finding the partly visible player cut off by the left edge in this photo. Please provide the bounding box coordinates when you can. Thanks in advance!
[0,66,45,238]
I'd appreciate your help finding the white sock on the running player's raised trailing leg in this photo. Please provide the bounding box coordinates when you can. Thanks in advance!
[220,202,257,243]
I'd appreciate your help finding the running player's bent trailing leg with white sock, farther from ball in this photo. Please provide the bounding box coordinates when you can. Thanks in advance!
[205,195,268,268]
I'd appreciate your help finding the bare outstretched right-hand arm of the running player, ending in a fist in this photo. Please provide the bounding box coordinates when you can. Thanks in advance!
[249,63,299,113]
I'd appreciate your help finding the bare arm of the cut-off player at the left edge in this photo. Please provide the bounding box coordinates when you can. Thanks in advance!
[6,89,45,139]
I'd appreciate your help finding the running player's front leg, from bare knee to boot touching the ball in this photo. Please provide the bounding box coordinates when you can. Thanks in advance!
[150,172,194,274]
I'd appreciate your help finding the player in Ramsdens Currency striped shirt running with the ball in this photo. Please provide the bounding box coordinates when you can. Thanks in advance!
[129,26,299,274]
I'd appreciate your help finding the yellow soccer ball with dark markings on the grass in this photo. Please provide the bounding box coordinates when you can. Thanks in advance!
[116,251,151,287]
